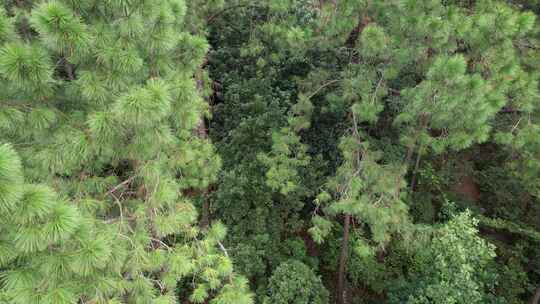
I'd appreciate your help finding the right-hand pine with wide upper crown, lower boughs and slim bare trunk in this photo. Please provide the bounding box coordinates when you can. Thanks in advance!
[298,1,536,303]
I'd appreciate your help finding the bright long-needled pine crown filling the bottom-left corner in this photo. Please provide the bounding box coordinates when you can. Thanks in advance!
[0,144,85,303]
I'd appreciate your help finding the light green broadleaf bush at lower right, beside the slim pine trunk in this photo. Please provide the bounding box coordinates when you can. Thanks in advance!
[388,212,496,303]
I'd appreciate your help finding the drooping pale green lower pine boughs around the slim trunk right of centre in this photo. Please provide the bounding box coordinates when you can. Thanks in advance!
[320,137,408,245]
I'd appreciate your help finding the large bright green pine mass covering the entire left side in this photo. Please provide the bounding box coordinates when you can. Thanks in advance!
[0,0,252,304]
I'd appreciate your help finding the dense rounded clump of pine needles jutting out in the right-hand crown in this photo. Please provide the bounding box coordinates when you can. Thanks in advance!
[396,56,502,153]
